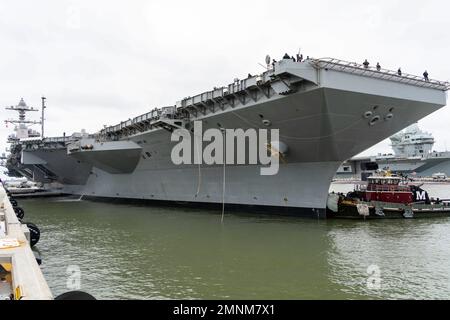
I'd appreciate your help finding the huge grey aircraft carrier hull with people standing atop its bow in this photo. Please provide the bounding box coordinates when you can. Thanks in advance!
[3,56,449,217]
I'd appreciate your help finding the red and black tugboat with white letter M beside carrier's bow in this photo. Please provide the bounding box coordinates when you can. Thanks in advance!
[327,173,450,219]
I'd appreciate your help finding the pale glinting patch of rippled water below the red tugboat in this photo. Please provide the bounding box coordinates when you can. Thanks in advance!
[328,218,450,299]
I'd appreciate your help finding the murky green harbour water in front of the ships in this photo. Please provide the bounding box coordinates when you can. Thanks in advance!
[19,199,450,299]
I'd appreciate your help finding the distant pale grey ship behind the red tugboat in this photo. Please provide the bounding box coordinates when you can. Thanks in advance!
[336,123,450,181]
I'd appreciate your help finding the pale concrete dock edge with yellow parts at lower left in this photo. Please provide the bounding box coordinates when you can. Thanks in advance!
[0,184,53,300]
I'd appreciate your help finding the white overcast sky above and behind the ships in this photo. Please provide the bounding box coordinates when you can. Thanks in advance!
[0,0,450,178]
